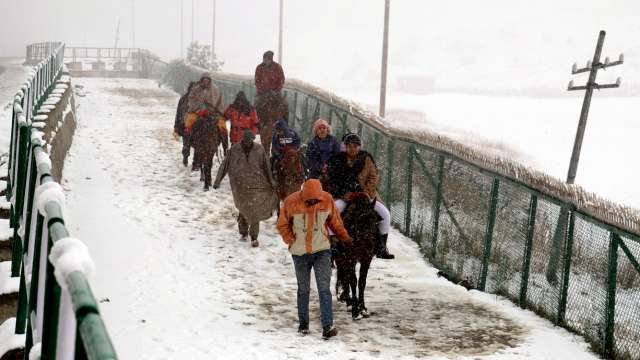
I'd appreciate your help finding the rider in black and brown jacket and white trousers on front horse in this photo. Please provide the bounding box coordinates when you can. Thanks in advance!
[327,133,395,259]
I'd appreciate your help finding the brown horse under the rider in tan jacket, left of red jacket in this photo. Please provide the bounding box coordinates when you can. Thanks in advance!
[191,115,222,191]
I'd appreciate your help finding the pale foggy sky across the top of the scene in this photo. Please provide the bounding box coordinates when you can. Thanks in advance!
[0,0,640,93]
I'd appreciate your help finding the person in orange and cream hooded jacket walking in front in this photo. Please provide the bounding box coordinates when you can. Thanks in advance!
[278,179,353,339]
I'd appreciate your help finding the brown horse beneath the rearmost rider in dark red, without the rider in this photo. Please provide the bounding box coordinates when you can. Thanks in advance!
[255,92,289,154]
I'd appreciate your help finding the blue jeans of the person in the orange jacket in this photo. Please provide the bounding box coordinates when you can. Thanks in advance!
[292,250,333,328]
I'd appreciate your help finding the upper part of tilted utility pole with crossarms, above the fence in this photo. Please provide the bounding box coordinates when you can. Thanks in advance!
[567,30,624,184]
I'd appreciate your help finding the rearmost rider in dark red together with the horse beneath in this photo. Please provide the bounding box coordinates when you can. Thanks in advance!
[254,51,289,154]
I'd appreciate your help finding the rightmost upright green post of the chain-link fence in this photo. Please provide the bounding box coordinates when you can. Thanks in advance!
[603,232,620,358]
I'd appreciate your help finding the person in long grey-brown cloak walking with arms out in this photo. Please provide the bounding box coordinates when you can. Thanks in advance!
[213,130,278,247]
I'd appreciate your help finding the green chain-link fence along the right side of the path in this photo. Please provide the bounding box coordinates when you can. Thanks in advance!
[162,66,640,359]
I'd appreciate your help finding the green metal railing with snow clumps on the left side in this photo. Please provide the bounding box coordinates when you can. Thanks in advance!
[6,43,117,359]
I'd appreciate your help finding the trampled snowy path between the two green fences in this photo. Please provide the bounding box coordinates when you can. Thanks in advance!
[63,79,596,359]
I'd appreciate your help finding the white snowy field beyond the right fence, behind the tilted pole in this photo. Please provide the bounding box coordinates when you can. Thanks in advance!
[336,88,640,209]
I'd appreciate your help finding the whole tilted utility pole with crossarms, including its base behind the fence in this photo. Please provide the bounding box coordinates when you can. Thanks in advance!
[546,30,624,285]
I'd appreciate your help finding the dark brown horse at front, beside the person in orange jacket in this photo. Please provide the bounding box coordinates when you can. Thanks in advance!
[334,193,381,320]
